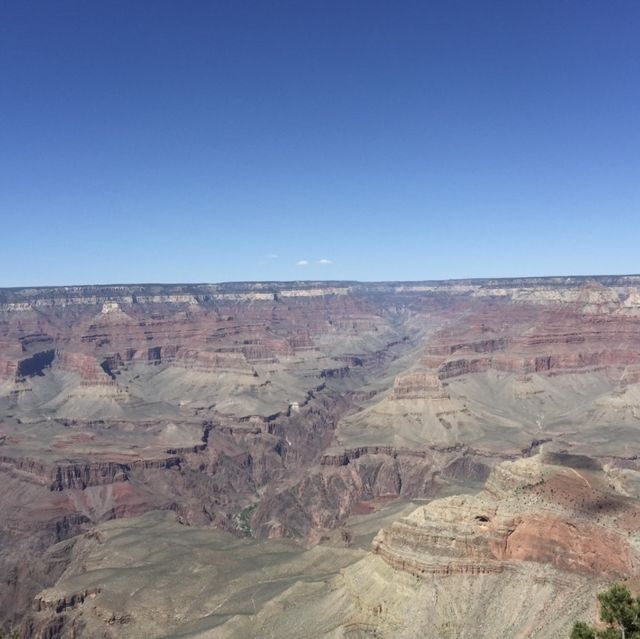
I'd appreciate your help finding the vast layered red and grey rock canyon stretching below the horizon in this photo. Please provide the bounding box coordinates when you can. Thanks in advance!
[0,275,640,639]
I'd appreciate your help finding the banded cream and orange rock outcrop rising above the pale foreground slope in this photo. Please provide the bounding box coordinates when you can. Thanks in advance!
[373,457,640,580]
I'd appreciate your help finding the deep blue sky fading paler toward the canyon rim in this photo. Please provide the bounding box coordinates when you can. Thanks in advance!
[0,0,640,286]
